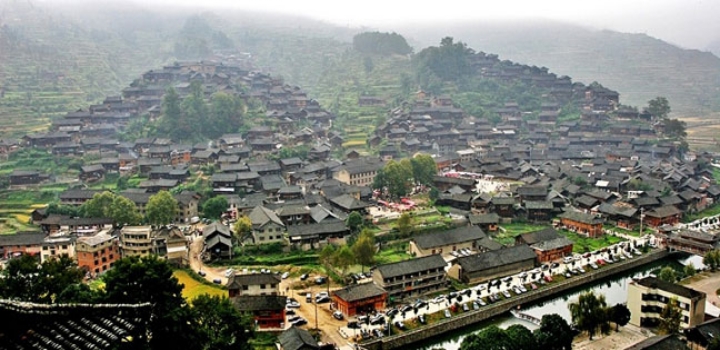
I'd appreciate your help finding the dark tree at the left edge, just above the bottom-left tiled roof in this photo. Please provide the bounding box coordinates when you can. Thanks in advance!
[0,254,85,303]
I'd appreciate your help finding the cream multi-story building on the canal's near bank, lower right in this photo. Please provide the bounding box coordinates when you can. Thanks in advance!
[627,276,706,328]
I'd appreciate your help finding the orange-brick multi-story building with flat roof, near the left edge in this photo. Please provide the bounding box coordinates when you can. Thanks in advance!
[75,232,120,274]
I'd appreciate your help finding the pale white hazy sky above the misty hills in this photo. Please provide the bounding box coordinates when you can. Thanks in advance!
[49,0,720,49]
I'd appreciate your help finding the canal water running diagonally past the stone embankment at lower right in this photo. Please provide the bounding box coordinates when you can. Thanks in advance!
[417,256,681,350]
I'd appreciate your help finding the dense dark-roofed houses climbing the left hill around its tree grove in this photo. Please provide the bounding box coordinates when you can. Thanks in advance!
[0,61,343,191]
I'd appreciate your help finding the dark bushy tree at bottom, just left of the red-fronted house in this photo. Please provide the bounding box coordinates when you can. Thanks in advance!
[191,294,253,350]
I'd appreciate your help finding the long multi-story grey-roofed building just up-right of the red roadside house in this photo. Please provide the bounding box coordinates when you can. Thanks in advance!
[373,254,447,301]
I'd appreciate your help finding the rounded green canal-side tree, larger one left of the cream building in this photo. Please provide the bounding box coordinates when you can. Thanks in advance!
[568,292,610,340]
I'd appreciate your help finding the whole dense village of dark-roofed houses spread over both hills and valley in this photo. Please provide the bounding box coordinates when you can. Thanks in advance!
[0,48,720,348]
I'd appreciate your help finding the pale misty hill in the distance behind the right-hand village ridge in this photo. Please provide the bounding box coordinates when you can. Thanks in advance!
[396,22,720,116]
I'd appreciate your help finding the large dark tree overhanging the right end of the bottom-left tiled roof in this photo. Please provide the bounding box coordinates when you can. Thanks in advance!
[102,255,202,349]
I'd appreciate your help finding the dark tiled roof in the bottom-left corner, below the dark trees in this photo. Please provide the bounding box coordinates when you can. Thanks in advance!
[0,300,151,350]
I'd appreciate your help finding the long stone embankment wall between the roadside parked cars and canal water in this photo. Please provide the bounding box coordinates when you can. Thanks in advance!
[362,250,670,350]
